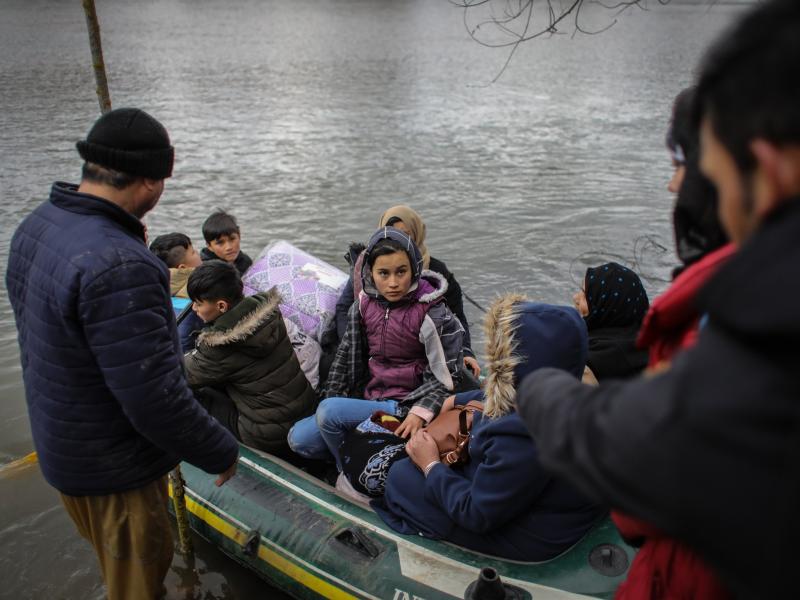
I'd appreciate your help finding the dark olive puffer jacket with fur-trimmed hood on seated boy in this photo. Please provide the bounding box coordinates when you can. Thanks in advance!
[186,288,316,452]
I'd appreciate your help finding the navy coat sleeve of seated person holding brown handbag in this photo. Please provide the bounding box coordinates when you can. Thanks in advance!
[424,422,550,533]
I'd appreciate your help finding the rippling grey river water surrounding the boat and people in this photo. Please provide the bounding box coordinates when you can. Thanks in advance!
[0,0,742,599]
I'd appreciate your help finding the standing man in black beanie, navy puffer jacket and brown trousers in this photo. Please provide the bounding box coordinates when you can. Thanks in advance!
[6,109,238,599]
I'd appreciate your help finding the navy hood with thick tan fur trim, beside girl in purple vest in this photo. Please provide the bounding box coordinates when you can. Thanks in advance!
[483,294,588,417]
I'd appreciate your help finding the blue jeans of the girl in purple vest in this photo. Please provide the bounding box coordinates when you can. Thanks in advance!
[287,398,398,471]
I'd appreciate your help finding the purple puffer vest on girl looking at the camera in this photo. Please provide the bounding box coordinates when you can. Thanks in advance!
[359,278,442,400]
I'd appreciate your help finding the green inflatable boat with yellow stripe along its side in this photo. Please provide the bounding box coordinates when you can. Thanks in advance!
[167,446,634,600]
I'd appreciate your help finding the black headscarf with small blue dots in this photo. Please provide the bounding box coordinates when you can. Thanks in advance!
[584,263,650,331]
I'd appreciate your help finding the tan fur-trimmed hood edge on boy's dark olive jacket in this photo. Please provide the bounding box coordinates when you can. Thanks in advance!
[197,288,283,347]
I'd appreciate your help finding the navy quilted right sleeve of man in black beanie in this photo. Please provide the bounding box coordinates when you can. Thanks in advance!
[78,262,239,473]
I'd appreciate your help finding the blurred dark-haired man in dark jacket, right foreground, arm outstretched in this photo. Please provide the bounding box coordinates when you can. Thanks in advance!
[519,0,800,598]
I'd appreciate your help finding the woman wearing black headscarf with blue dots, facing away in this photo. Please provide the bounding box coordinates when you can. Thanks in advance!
[573,262,650,381]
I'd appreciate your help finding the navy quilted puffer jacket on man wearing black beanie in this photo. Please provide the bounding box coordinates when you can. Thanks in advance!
[6,183,238,496]
